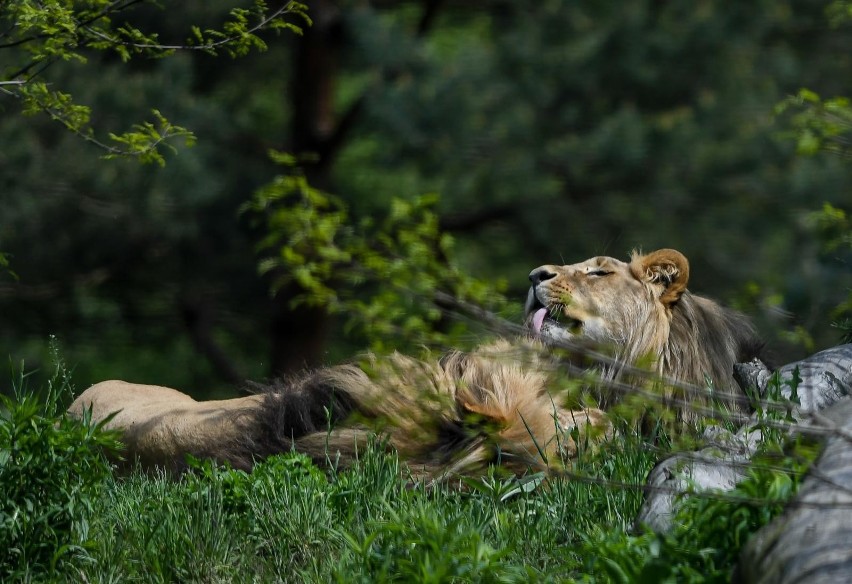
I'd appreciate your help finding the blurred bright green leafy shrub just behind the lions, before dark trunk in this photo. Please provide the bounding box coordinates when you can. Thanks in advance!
[243,152,506,351]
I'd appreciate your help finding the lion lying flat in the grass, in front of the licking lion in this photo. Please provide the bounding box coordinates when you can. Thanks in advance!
[70,342,608,478]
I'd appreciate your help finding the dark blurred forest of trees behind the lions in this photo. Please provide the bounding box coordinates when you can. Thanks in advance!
[0,0,852,395]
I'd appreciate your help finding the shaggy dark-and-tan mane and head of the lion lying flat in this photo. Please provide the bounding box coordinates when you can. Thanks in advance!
[216,342,604,478]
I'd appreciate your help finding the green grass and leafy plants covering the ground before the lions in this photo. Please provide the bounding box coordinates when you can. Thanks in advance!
[0,358,804,583]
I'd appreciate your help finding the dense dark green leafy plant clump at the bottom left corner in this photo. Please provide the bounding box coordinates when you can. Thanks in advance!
[0,346,119,581]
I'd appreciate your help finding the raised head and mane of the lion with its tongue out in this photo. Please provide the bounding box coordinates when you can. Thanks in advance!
[526,249,761,409]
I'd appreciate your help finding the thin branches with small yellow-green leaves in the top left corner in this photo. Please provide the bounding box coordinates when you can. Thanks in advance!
[0,0,311,165]
